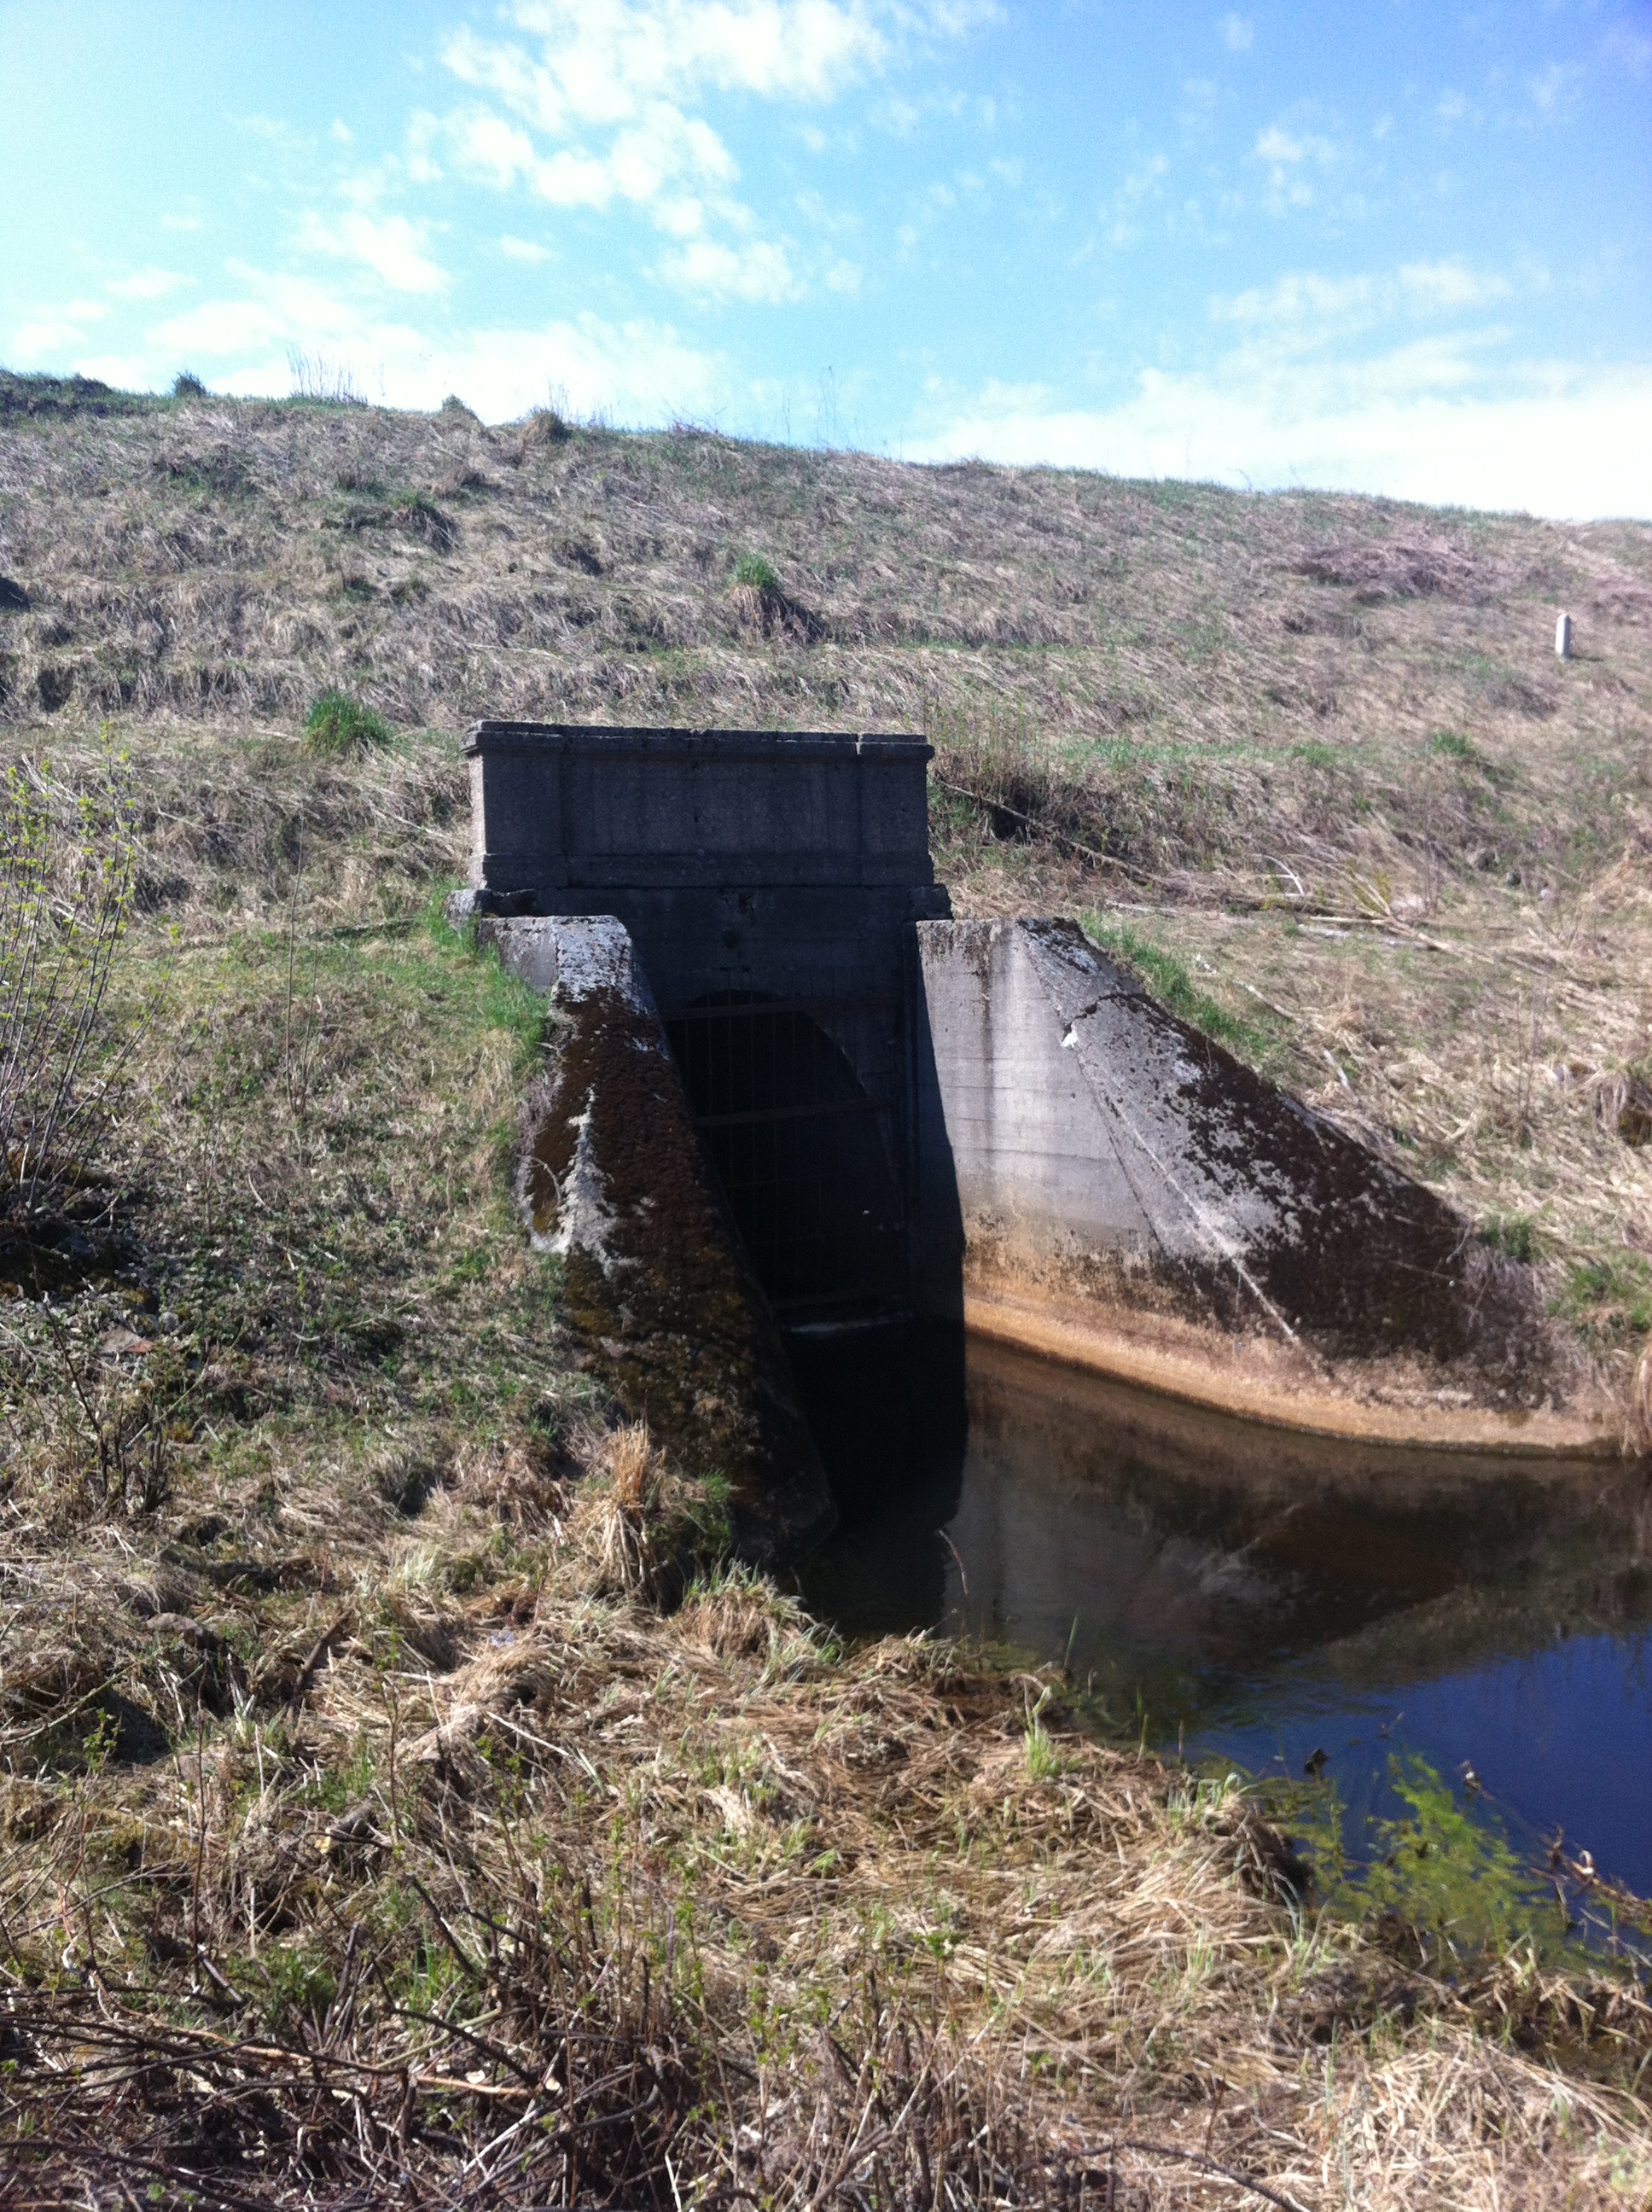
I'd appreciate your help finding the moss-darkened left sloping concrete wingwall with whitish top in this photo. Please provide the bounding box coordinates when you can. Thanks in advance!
[478,916,836,1564]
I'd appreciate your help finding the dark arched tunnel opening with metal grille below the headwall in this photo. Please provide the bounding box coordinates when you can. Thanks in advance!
[666,991,907,1323]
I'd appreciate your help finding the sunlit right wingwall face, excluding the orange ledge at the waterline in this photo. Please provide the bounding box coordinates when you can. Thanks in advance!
[916,920,1530,1374]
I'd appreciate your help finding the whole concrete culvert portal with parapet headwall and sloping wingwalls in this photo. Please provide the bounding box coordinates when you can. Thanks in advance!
[456,721,1599,1557]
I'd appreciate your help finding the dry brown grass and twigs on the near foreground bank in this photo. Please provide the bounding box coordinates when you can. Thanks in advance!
[0,1431,1652,2208]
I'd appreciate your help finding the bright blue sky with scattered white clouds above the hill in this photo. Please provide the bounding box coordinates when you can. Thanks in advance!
[0,0,1652,515]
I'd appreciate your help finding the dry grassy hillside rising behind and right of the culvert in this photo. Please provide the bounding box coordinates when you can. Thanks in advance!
[0,376,1652,1405]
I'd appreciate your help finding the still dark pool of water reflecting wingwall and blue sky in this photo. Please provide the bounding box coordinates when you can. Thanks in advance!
[792,1327,1652,1894]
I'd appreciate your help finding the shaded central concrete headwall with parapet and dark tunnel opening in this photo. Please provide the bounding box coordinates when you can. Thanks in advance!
[462,721,949,1318]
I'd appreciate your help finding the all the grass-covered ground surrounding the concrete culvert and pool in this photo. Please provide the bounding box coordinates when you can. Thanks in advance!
[0,378,1652,2212]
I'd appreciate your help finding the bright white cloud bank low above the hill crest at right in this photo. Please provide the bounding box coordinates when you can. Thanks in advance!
[907,356,1652,518]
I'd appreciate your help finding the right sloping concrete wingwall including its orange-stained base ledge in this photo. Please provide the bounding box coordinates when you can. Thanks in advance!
[913,920,1603,1451]
